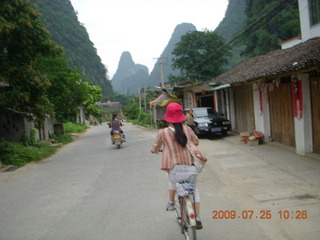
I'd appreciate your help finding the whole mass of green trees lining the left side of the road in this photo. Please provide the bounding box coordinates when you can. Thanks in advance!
[0,0,102,124]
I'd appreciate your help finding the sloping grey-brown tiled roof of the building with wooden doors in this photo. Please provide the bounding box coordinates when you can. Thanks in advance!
[212,37,320,84]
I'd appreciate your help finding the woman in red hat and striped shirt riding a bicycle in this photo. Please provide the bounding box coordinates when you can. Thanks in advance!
[151,102,206,229]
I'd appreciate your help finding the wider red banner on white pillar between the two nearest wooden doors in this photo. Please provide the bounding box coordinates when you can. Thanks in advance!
[292,78,303,119]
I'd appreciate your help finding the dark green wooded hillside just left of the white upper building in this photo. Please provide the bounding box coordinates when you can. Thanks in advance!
[241,0,300,57]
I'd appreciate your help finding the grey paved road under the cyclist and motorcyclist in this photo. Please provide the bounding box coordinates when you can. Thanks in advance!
[0,124,318,240]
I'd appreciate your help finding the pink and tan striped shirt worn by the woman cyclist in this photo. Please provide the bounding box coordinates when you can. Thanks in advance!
[151,125,199,170]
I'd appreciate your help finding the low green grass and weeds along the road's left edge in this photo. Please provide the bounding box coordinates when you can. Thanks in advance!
[0,123,87,167]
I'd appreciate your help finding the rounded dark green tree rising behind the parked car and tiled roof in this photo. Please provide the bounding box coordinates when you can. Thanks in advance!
[170,29,230,81]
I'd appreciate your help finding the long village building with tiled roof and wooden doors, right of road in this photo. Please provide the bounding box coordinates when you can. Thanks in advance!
[176,0,320,155]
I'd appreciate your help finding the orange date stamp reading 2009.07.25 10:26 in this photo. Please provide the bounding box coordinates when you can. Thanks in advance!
[212,210,308,219]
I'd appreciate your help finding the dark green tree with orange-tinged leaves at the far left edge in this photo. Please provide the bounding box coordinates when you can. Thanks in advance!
[0,0,62,122]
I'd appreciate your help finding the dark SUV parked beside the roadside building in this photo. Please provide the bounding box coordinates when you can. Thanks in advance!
[186,107,231,135]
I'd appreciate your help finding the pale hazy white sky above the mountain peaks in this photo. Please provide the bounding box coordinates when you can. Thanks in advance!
[71,0,228,79]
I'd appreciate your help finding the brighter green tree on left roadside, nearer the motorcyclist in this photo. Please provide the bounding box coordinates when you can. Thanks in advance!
[37,57,102,122]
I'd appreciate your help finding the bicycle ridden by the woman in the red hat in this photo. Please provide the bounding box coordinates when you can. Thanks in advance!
[168,165,198,240]
